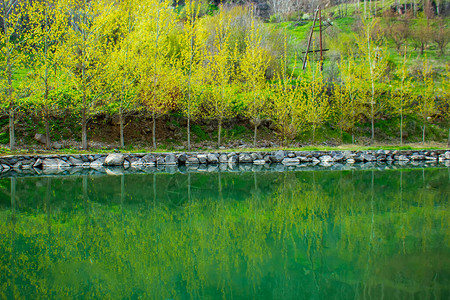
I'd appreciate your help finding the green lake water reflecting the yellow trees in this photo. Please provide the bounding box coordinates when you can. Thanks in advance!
[0,168,450,299]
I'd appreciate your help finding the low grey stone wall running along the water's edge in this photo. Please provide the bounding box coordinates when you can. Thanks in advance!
[0,150,450,174]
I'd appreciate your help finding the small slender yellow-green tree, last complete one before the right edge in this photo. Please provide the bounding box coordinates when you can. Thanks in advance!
[416,59,436,144]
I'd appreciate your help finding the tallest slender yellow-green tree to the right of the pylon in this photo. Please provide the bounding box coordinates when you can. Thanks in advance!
[356,19,387,142]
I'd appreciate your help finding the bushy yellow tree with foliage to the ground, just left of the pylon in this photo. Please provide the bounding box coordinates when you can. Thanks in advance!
[271,36,306,144]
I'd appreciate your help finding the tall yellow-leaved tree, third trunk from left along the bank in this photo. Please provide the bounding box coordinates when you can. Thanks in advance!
[64,0,112,149]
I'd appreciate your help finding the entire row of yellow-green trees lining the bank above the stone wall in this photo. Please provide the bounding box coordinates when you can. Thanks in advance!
[0,0,450,150]
